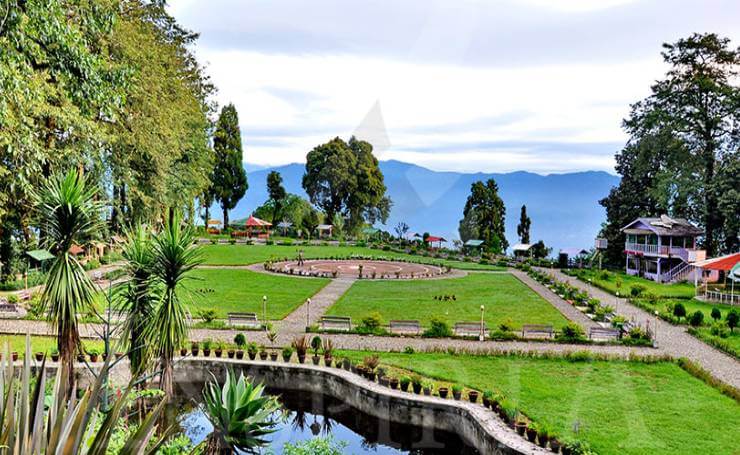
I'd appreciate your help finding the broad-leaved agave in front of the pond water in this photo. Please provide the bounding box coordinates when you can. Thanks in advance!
[203,369,280,453]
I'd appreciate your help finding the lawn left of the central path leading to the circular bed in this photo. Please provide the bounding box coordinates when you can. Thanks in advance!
[185,269,329,320]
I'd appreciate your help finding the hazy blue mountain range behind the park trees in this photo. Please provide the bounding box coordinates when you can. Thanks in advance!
[213,160,619,252]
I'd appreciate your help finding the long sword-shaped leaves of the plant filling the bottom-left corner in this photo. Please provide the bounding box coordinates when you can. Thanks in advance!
[0,335,169,455]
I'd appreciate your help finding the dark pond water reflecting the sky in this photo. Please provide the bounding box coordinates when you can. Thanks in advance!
[177,389,479,455]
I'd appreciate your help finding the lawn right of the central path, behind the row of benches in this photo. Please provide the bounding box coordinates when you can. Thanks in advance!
[328,273,567,328]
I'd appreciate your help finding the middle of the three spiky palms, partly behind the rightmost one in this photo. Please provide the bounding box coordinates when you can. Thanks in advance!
[115,225,156,378]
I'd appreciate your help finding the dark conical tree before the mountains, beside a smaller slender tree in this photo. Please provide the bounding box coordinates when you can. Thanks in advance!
[463,179,509,253]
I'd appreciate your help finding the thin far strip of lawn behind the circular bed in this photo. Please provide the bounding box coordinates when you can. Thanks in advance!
[202,244,503,270]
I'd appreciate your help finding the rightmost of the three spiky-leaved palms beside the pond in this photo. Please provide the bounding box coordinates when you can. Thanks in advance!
[147,211,202,396]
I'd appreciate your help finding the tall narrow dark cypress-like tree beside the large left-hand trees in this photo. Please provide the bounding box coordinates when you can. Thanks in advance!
[213,104,248,227]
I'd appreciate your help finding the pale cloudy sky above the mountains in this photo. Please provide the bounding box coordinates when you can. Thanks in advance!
[170,0,740,173]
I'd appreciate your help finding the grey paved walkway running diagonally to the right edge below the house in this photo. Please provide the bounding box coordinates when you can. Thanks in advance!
[542,269,740,388]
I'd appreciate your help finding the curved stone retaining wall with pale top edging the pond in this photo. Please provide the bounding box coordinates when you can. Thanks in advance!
[175,357,551,454]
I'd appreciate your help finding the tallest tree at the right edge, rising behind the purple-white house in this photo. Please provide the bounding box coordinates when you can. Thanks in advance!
[624,33,740,255]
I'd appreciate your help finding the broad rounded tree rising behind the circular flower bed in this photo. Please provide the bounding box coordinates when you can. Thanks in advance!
[303,137,392,230]
